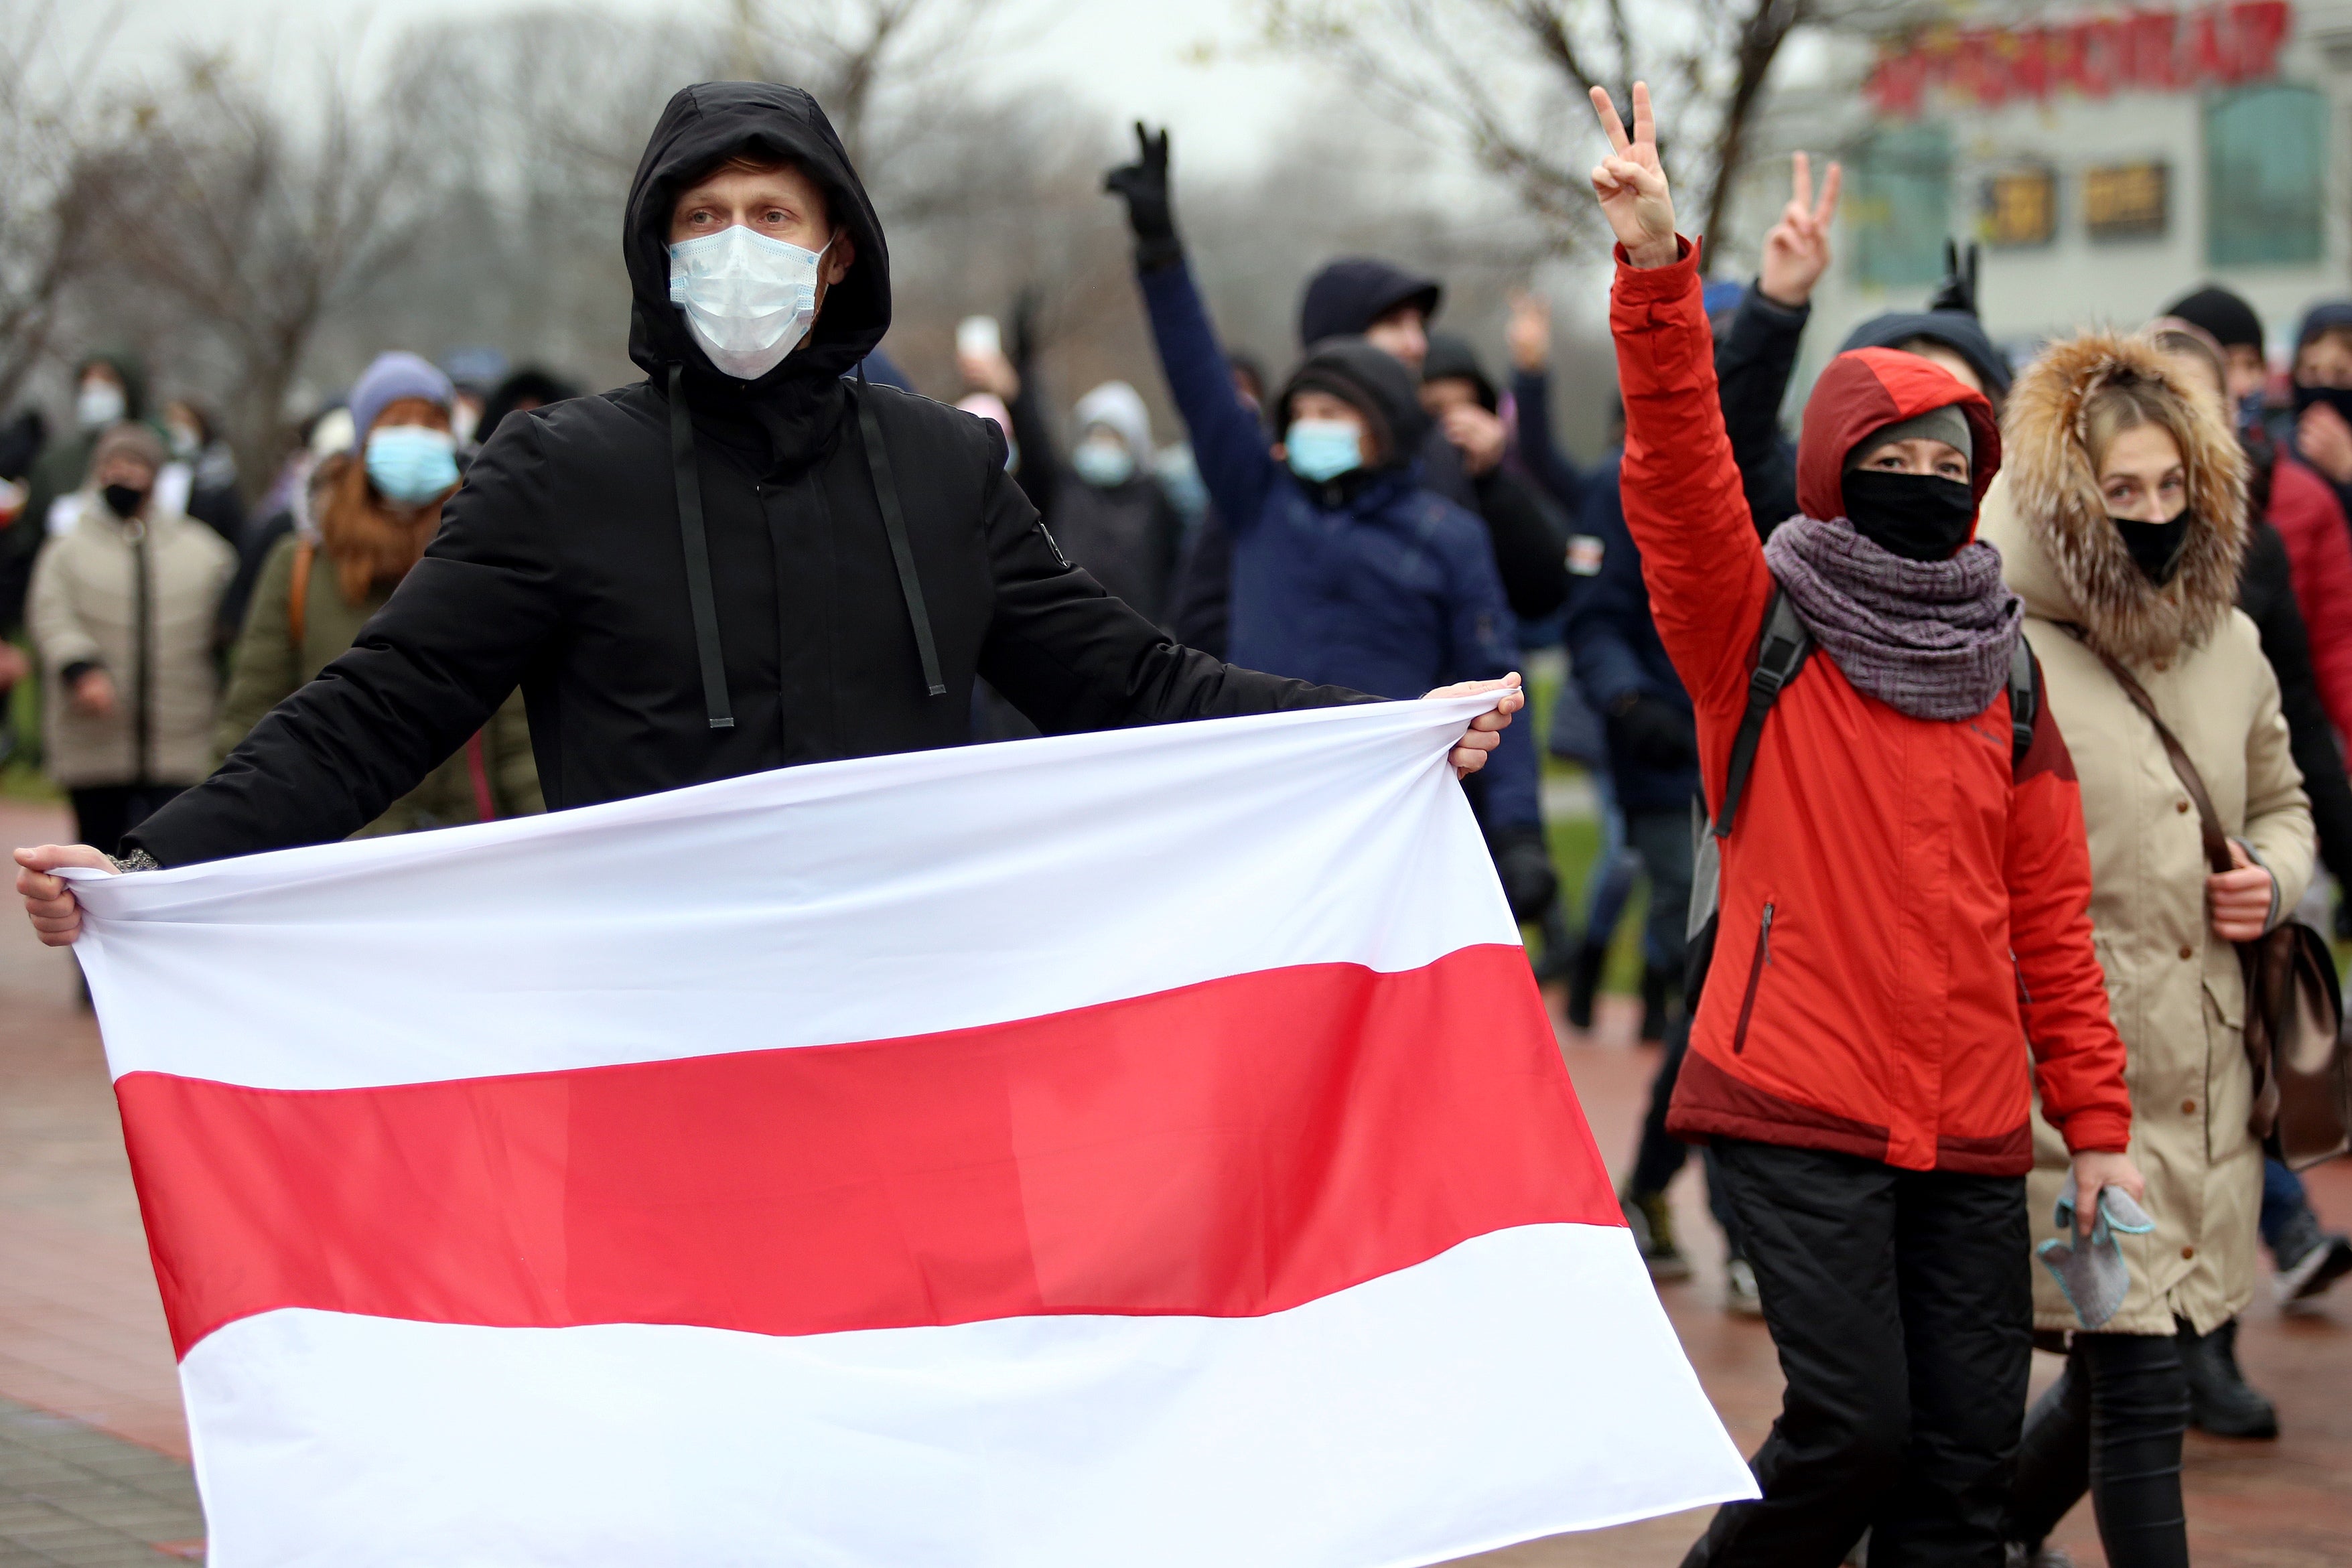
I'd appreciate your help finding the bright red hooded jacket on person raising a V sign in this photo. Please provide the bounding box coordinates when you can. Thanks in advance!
[1611,252,2131,1175]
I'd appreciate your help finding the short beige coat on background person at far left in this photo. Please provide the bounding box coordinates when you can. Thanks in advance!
[26,496,238,790]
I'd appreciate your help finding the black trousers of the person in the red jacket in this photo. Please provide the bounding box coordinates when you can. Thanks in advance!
[1684,1140,2032,1568]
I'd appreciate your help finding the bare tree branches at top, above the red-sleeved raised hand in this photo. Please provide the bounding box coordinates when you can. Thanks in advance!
[1261,0,1915,249]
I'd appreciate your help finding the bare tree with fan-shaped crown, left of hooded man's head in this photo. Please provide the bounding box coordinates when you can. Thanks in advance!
[98,56,442,475]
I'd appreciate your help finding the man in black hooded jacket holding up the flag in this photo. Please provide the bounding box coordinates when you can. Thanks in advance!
[19,82,1522,942]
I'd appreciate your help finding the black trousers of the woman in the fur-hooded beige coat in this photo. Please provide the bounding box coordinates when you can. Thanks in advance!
[2006,1333,2190,1568]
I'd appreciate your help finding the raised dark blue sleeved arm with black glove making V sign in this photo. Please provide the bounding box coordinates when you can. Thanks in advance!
[1103,125,1282,536]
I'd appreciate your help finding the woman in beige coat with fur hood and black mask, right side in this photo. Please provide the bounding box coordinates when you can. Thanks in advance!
[1983,334,2312,1568]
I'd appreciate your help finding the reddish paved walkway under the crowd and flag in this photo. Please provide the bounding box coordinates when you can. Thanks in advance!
[0,802,2352,1568]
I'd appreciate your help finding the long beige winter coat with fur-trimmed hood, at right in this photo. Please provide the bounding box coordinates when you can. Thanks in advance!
[1980,336,2312,1333]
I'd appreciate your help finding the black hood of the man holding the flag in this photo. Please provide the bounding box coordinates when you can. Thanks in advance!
[621,82,889,416]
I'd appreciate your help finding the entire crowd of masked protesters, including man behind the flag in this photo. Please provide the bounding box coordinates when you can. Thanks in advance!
[0,70,2352,1568]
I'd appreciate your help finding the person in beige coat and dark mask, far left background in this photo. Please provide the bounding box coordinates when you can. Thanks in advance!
[26,423,238,853]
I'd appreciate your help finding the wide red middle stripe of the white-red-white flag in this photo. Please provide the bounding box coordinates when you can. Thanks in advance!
[115,945,1620,1354]
